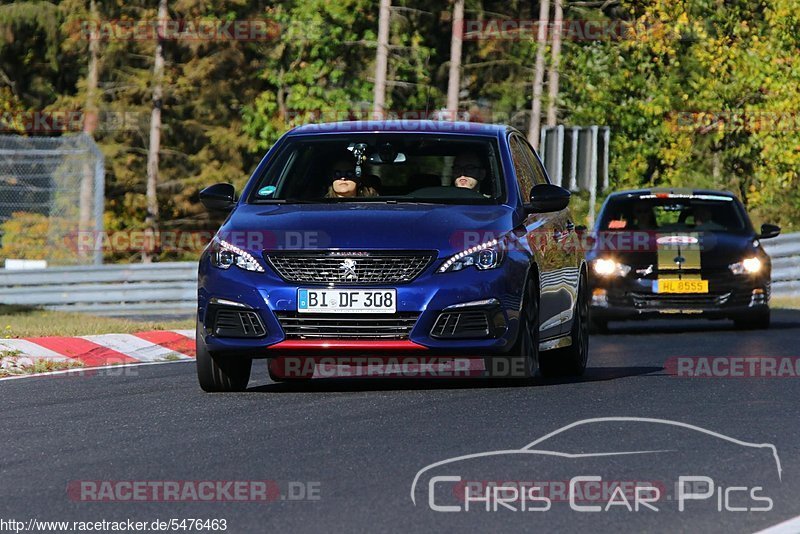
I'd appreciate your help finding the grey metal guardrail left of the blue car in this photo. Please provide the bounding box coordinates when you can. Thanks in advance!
[0,262,197,316]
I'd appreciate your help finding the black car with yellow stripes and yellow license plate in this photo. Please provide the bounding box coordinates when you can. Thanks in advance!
[587,189,780,332]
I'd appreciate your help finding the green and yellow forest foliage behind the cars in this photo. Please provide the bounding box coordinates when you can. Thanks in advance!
[0,0,800,261]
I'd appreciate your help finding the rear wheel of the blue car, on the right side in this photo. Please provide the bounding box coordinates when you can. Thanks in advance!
[539,276,589,377]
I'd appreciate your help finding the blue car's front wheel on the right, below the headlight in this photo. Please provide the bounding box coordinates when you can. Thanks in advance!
[484,280,539,383]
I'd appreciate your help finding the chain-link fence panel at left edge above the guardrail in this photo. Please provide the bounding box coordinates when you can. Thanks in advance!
[0,134,105,265]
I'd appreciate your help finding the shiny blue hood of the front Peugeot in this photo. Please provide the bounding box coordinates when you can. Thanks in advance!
[220,202,514,255]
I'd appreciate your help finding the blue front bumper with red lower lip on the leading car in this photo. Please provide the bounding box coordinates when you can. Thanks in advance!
[198,252,526,358]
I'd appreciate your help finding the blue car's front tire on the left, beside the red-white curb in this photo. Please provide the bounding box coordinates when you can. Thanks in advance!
[195,322,253,393]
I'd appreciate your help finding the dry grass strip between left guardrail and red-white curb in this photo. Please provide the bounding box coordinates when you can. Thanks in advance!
[0,304,194,338]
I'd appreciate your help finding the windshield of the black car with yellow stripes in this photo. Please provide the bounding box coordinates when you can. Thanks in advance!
[598,195,746,233]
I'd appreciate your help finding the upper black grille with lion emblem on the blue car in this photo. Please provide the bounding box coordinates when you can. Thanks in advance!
[264,251,434,285]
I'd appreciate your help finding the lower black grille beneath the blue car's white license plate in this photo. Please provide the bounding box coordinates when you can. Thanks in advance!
[275,312,419,339]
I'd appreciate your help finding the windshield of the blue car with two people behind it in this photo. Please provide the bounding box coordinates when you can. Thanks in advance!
[249,133,503,204]
